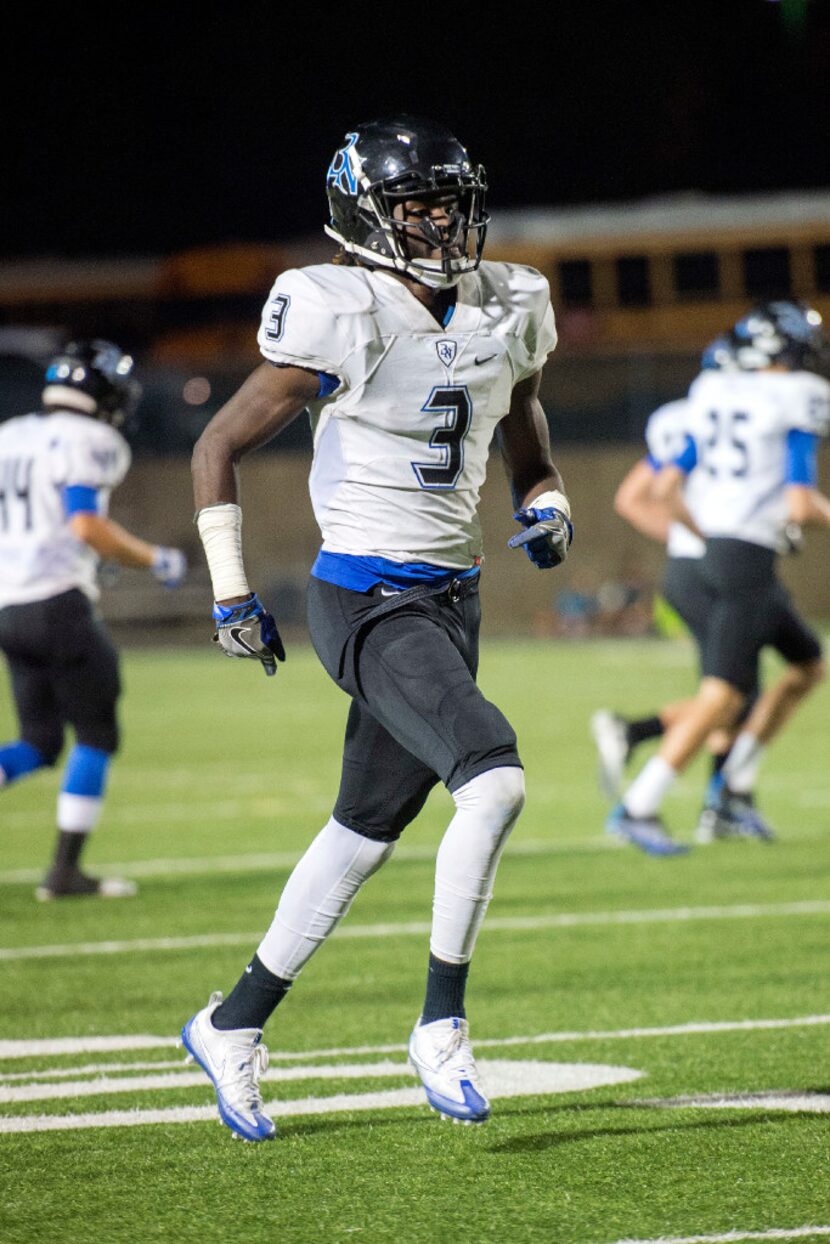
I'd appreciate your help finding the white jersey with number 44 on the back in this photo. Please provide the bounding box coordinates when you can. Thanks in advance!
[0,411,131,607]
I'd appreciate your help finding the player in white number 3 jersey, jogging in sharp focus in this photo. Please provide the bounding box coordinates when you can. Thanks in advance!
[182,117,571,1140]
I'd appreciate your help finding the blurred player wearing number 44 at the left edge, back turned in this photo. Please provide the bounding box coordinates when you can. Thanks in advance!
[0,340,185,899]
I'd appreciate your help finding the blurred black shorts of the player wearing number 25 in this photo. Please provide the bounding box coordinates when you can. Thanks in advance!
[701,537,821,694]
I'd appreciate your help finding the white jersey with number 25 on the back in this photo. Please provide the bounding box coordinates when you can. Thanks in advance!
[687,371,830,549]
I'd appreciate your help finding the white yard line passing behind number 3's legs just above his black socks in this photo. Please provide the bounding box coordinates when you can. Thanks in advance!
[0,898,830,962]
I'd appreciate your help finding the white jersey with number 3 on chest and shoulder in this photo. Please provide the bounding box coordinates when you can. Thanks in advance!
[258,262,556,569]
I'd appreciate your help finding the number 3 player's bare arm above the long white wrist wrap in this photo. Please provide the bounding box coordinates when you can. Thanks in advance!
[192,363,319,511]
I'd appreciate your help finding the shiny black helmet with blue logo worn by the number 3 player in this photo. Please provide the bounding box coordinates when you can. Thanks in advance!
[325,116,489,289]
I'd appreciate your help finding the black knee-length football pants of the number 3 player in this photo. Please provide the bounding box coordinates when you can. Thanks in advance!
[307,576,521,841]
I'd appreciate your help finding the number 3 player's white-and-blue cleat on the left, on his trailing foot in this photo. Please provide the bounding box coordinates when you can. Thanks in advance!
[182,993,276,1141]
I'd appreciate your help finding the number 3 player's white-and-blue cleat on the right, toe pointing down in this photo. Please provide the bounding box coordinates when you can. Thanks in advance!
[409,1019,490,1123]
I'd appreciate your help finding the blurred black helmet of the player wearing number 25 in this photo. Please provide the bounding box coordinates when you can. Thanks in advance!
[732,300,829,373]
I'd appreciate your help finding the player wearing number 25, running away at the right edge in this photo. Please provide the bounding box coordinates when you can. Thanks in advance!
[607,302,830,840]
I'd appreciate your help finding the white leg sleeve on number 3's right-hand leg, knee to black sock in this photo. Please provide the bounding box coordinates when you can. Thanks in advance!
[429,765,525,963]
